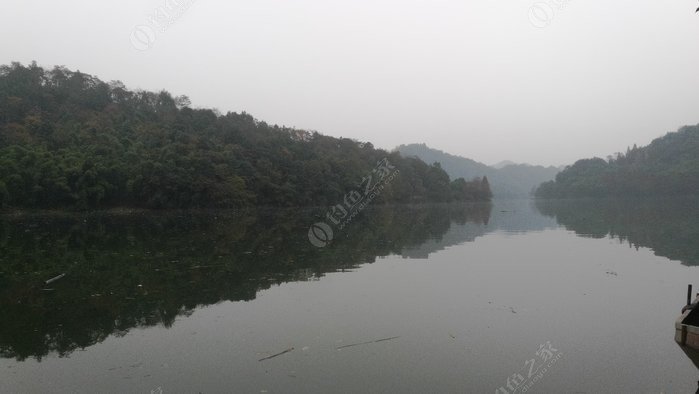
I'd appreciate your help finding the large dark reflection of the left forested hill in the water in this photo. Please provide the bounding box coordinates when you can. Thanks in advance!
[0,204,492,360]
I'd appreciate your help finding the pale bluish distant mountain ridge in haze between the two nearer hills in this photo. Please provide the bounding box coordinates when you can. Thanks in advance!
[395,144,560,199]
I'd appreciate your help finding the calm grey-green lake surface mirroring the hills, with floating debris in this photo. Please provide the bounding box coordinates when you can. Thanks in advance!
[0,200,699,393]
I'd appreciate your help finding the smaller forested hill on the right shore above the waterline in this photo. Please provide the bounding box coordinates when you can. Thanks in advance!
[536,126,699,198]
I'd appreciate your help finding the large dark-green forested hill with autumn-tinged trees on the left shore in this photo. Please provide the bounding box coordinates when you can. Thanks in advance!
[0,63,490,209]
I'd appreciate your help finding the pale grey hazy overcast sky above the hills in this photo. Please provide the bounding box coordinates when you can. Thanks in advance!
[0,0,699,165]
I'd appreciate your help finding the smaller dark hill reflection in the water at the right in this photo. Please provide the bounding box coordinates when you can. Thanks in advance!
[536,199,699,266]
